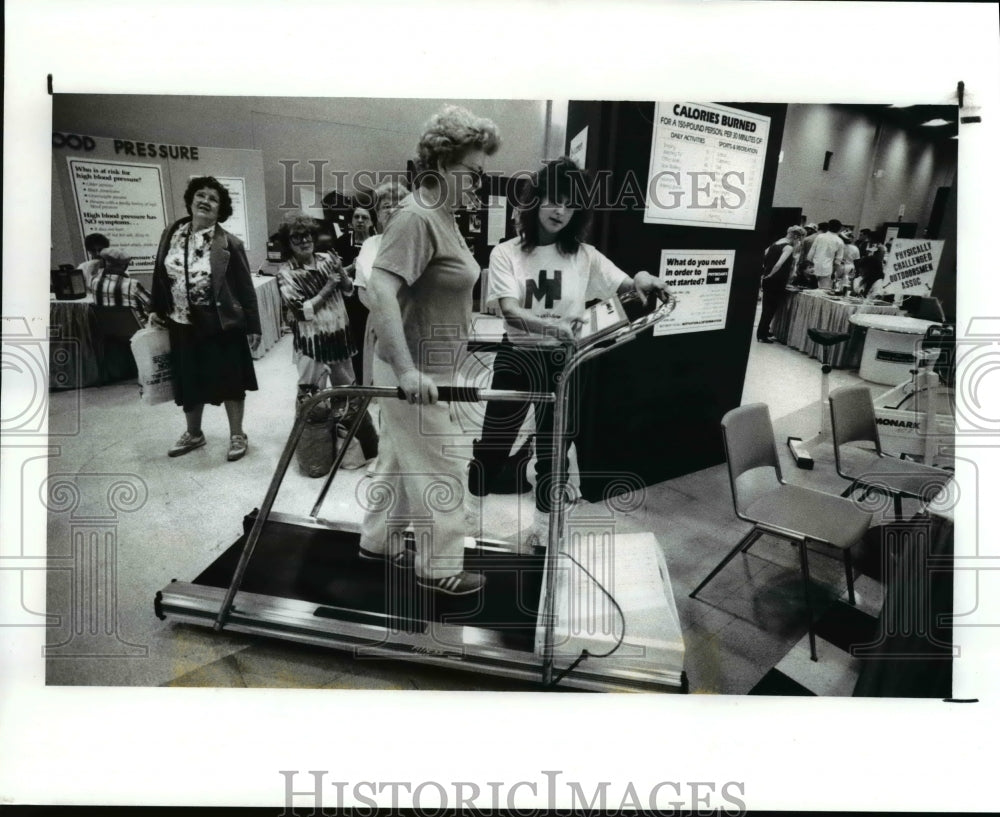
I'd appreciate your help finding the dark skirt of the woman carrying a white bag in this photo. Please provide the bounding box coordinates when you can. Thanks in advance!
[170,321,257,411]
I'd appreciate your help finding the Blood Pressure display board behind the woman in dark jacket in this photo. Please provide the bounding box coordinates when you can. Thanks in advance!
[51,133,267,283]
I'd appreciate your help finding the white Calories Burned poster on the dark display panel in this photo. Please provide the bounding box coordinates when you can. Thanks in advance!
[643,102,771,230]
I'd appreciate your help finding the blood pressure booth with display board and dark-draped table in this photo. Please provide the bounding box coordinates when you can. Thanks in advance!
[49,132,281,389]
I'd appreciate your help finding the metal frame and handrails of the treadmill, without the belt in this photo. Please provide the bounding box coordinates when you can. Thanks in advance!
[154,297,687,692]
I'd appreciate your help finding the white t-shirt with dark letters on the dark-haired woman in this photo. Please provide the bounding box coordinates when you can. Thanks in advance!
[487,238,630,344]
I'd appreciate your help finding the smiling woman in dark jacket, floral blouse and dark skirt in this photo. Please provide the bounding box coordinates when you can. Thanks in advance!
[150,176,260,462]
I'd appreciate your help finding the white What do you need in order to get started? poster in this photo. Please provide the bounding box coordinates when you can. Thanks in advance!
[653,250,736,335]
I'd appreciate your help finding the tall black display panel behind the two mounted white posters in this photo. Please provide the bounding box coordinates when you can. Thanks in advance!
[567,102,787,501]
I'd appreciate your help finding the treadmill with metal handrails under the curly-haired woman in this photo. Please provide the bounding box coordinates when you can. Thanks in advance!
[154,296,687,692]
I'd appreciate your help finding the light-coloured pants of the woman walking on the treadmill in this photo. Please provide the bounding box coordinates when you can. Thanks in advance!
[358,357,468,579]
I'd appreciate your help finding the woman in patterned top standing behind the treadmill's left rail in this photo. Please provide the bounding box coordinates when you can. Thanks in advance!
[277,213,378,460]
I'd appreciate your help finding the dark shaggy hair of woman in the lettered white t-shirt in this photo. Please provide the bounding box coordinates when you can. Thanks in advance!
[514,156,592,255]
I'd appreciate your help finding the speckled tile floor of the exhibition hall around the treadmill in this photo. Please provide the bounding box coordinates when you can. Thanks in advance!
[39,306,932,694]
